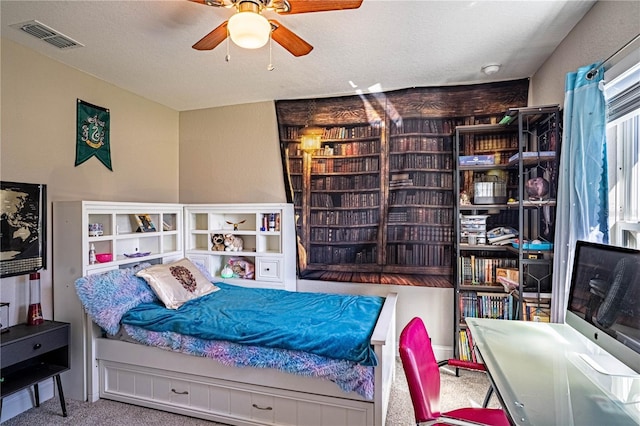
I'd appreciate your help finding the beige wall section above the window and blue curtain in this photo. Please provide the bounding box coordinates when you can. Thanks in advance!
[529,0,640,107]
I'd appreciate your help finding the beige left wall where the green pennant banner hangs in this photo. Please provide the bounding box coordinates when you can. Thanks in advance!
[0,39,179,323]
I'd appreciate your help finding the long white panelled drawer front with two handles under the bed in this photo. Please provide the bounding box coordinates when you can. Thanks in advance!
[100,361,373,426]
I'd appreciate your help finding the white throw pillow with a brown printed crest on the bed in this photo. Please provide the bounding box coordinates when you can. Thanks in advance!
[136,259,220,309]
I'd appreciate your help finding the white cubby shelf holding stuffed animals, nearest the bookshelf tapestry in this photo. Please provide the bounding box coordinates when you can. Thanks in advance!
[184,203,296,291]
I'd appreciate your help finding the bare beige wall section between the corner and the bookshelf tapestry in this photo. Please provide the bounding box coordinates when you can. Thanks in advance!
[180,102,286,204]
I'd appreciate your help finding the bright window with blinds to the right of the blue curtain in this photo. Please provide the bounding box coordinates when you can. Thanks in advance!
[604,56,640,248]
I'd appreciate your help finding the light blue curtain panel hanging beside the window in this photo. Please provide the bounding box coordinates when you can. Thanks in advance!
[551,64,608,322]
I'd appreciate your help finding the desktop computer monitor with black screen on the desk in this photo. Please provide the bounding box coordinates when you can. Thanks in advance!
[567,241,640,373]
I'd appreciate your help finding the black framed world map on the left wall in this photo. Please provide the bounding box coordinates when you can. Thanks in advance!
[0,181,47,278]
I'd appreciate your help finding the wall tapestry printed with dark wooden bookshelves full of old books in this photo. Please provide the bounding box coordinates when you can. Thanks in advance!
[276,79,529,287]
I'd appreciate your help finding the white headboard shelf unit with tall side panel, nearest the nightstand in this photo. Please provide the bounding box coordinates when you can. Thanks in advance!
[53,201,184,401]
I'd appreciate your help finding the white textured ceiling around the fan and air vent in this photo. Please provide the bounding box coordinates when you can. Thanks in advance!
[0,0,595,111]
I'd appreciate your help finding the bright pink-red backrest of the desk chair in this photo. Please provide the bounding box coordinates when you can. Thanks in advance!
[399,317,440,423]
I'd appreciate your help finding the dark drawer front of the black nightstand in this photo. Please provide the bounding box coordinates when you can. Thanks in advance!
[0,327,69,368]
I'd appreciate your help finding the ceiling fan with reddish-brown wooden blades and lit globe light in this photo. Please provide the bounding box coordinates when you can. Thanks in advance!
[189,0,362,56]
